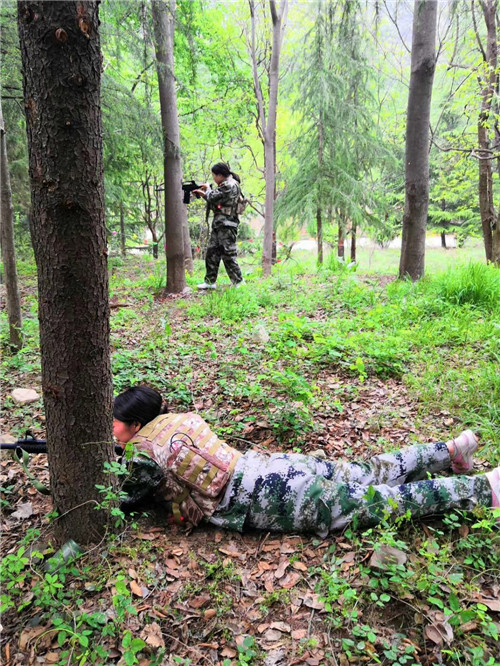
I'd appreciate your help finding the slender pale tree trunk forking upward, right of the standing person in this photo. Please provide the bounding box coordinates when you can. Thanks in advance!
[248,0,288,276]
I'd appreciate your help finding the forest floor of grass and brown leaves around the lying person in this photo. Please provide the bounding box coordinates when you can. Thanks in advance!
[0,253,500,666]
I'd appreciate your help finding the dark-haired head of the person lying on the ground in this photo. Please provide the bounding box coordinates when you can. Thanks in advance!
[113,386,162,444]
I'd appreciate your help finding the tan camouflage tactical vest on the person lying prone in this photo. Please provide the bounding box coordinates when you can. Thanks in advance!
[130,413,241,525]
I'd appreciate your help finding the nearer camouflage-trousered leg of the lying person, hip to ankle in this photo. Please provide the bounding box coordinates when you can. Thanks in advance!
[213,451,500,537]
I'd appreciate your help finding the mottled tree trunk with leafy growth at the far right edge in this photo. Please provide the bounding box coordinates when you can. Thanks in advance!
[477,0,500,265]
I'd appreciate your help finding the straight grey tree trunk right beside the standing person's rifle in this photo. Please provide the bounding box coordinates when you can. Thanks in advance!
[151,0,187,294]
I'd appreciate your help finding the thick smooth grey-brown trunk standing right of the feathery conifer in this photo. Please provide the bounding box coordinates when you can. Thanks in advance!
[399,0,437,280]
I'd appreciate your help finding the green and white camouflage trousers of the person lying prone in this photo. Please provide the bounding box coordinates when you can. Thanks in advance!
[210,442,492,537]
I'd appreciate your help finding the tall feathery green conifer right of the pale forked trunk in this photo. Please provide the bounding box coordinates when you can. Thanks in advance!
[276,0,389,243]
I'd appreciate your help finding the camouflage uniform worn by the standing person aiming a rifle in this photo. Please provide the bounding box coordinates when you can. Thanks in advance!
[205,176,243,284]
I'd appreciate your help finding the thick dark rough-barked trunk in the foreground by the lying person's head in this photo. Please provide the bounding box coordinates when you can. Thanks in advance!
[18,1,114,544]
